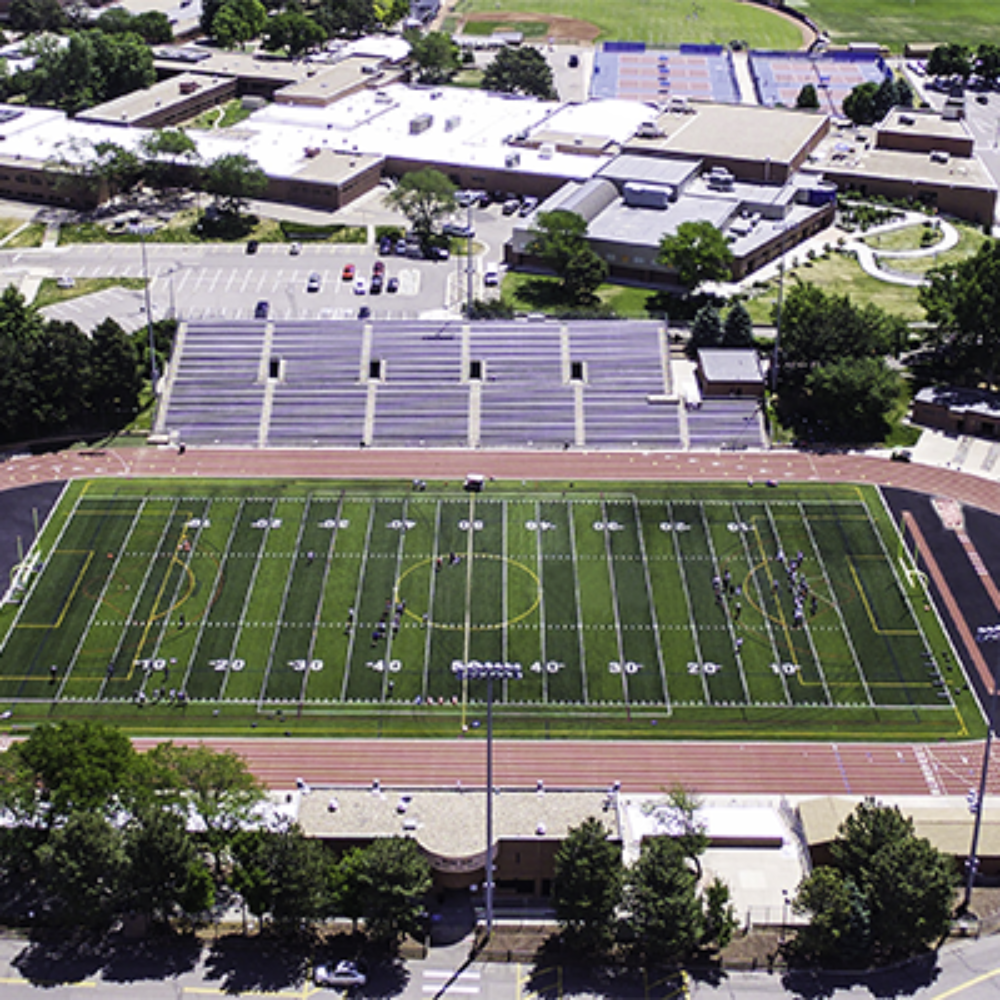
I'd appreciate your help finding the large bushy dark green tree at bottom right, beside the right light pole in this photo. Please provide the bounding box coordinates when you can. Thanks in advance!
[792,799,958,964]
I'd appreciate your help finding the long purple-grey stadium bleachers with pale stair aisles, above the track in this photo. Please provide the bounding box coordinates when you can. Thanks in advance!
[157,320,764,449]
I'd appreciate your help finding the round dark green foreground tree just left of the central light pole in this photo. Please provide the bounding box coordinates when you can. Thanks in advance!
[338,837,431,944]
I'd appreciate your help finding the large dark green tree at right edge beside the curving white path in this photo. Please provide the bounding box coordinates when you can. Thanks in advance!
[917,240,1000,385]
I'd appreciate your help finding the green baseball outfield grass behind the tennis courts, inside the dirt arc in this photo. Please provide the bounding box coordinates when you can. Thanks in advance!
[455,0,802,49]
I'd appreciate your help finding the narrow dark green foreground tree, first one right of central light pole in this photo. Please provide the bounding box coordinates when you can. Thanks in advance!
[552,818,624,952]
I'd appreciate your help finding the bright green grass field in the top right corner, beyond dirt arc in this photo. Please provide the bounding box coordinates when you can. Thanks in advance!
[789,0,1000,52]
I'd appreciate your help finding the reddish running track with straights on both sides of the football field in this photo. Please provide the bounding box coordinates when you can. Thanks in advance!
[0,448,1000,795]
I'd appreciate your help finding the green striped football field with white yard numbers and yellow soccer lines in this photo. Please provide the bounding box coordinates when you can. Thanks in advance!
[0,480,979,738]
